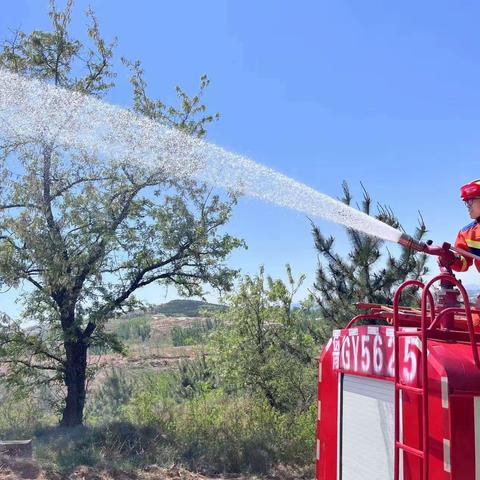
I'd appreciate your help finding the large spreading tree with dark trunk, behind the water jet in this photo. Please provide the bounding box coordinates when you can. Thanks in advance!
[0,0,243,426]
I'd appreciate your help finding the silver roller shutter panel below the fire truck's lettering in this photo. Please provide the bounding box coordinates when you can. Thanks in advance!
[339,375,395,480]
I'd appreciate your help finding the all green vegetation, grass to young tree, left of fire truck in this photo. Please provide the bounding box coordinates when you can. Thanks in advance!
[0,269,321,473]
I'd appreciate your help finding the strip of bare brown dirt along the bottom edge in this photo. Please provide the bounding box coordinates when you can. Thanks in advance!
[0,457,311,480]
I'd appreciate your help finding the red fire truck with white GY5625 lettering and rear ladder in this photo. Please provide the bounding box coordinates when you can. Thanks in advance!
[316,237,480,480]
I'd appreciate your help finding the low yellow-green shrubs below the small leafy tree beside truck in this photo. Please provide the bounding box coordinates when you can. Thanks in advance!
[167,390,315,473]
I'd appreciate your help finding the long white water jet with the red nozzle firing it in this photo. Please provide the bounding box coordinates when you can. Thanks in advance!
[0,68,480,278]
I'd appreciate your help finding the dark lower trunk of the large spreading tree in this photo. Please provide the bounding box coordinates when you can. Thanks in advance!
[61,340,87,427]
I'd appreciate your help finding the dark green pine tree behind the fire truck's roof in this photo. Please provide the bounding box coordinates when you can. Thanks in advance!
[312,182,428,327]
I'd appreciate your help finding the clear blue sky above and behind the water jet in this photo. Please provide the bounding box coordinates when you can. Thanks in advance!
[0,0,480,312]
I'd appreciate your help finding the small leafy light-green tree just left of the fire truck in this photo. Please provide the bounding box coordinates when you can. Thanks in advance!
[210,266,318,411]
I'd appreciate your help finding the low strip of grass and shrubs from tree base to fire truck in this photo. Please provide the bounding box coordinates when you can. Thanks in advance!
[36,391,316,474]
